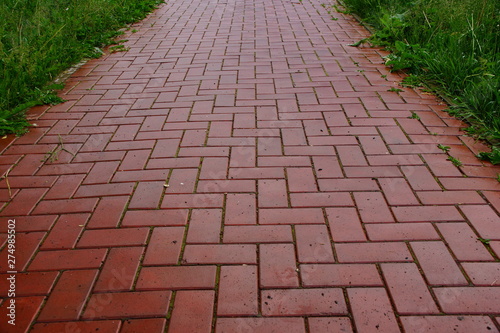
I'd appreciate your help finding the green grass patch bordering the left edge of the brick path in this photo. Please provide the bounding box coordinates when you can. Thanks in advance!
[0,0,163,135]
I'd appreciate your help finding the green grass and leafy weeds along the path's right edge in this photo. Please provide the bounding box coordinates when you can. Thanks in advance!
[344,0,500,145]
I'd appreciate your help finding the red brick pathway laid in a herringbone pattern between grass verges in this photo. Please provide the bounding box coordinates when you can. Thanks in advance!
[0,0,500,333]
